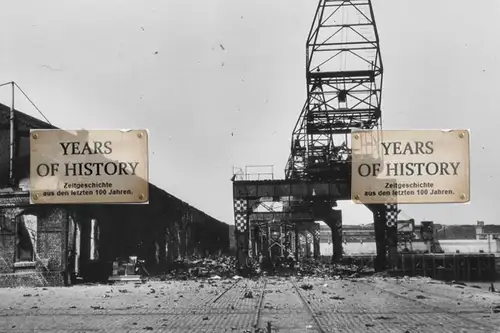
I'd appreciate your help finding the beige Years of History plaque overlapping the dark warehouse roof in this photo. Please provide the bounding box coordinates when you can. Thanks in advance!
[30,129,149,204]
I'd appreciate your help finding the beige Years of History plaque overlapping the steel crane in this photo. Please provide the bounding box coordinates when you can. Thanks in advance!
[351,130,470,204]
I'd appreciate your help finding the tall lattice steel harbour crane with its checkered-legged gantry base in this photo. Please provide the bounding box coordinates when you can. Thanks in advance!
[233,0,404,267]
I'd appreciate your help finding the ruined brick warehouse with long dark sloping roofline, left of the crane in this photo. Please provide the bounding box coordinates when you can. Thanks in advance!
[0,104,229,286]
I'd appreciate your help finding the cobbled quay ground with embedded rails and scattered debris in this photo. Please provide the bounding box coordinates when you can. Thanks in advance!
[0,277,500,333]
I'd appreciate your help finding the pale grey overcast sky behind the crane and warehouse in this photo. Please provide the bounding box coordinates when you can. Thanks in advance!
[0,0,500,224]
